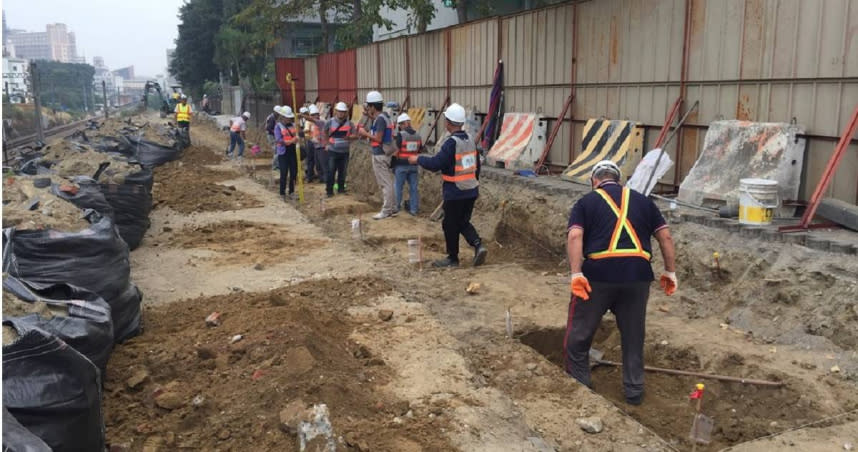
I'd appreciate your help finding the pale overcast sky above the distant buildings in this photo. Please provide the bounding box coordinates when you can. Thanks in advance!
[3,0,184,77]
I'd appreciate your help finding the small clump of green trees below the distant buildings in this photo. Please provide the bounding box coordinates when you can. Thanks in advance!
[36,61,95,111]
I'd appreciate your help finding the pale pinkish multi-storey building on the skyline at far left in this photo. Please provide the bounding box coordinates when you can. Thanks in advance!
[5,23,81,63]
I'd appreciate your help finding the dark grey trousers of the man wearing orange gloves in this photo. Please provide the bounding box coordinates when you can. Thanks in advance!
[563,281,650,398]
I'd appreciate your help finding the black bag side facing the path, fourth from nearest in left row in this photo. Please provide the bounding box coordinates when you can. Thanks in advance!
[99,183,152,250]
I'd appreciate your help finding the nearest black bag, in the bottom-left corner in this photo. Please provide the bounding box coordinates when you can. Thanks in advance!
[3,328,104,452]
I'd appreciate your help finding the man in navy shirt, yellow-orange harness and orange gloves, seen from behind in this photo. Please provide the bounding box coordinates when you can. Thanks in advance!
[564,160,677,405]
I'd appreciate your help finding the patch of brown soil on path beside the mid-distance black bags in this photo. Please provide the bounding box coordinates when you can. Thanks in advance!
[152,161,262,213]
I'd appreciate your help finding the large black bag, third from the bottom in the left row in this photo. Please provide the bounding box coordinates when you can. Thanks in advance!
[3,214,142,342]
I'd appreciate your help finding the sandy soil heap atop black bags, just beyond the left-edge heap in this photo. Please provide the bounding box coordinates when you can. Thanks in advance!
[42,141,140,184]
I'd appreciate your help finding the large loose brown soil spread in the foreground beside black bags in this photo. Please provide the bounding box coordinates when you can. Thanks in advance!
[104,279,453,451]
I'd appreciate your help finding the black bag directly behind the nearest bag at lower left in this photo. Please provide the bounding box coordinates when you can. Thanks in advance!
[3,276,113,375]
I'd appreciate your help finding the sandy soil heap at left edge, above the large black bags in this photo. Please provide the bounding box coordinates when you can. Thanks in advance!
[3,176,89,232]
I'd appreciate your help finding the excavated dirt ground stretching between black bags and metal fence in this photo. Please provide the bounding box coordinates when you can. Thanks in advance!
[105,118,858,451]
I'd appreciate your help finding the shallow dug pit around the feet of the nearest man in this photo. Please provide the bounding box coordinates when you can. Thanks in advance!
[518,319,825,451]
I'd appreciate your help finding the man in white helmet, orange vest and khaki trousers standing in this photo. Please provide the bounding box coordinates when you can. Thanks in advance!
[358,91,397,220]
